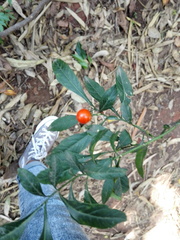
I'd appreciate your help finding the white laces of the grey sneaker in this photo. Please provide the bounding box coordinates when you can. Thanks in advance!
[28,128,55,160]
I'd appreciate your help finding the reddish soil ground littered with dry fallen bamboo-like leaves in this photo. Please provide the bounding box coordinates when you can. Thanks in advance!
[0,0,180,240]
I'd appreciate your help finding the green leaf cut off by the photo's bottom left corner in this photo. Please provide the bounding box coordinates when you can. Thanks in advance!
[0,210,37,240]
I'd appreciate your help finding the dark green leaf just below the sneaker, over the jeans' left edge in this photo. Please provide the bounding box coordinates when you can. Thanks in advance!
[18,168,45,196]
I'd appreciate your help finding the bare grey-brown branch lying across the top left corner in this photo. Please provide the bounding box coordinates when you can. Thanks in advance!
[0,0,51,38]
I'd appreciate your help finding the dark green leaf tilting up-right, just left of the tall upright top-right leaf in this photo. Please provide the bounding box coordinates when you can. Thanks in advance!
[99,85,117,112]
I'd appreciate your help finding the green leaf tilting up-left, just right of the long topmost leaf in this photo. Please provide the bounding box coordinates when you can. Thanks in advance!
[84,77,105,102]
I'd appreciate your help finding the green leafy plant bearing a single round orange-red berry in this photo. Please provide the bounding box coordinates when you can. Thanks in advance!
[0,59,179,240]
